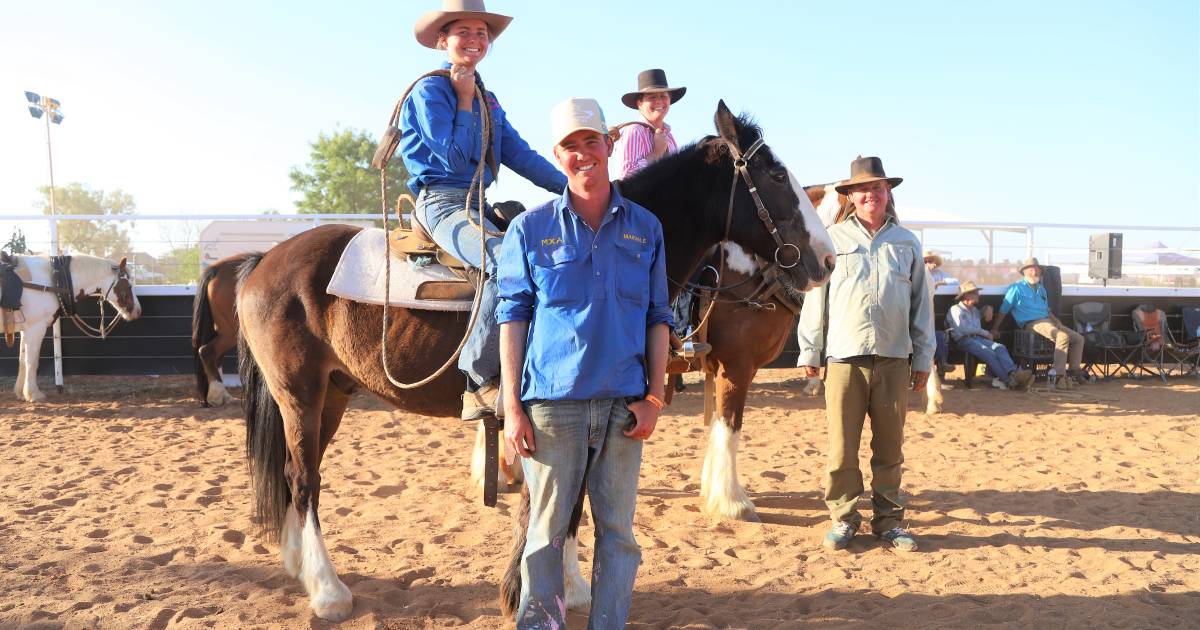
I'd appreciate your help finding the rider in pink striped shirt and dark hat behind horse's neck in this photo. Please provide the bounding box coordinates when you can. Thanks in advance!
[613,68,688,179]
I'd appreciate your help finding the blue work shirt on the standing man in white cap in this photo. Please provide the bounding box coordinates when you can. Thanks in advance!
[496,187,672,401]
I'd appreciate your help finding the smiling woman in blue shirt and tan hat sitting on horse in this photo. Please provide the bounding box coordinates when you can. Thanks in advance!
[400,0,566,420]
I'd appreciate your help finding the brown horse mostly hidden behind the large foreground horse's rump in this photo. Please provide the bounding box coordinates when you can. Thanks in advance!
[192,253,253,407]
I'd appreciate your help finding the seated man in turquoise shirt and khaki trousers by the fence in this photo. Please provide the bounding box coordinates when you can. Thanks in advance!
[991,258,1087,389]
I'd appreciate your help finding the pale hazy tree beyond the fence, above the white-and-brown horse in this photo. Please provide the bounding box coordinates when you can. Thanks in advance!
[38,184,137,259]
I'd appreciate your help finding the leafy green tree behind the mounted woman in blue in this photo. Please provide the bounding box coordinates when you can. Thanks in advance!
[288,130,408,214]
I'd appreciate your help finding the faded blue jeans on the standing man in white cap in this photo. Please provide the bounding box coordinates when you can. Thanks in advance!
[517,398,642,629]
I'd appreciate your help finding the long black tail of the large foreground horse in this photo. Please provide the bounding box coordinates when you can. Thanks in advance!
[238,254,292,540]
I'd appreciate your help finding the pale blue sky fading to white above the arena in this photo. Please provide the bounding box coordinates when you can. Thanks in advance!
[0,0,1200,254]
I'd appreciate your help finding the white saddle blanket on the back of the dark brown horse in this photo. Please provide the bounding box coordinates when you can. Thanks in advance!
[325,228,472,311]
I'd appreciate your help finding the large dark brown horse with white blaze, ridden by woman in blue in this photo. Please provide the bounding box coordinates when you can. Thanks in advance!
[238,103,834,619]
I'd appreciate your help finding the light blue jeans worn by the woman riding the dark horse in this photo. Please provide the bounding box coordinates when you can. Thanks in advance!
[414,186,504,385]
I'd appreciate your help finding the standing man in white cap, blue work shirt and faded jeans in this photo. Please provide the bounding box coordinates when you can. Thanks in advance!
[496,98,671,628]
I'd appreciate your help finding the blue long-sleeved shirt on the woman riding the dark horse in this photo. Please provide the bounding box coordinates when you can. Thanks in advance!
[398,64,566,194]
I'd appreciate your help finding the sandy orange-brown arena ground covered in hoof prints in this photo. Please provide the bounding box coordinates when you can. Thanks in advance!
[0,370,1200,629]
